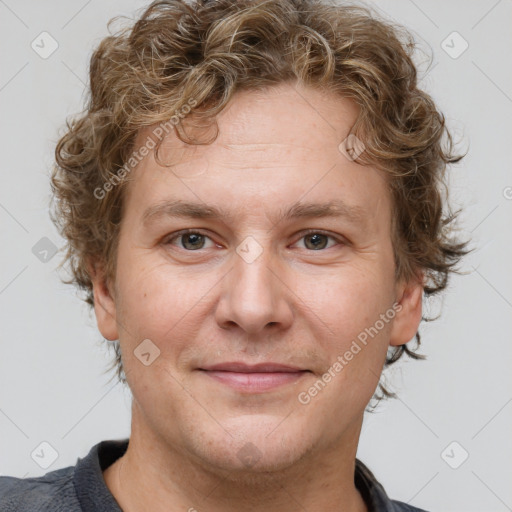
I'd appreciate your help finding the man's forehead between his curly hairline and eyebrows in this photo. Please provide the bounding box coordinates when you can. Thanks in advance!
[122,84,390,226]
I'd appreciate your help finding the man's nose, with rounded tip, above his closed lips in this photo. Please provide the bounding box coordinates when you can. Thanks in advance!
[215,241,293,334]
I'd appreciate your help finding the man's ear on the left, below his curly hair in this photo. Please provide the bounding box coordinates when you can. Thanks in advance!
[87,261,119,341]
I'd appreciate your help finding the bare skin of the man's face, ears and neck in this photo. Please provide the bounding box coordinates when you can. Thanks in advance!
[91,83,422,512]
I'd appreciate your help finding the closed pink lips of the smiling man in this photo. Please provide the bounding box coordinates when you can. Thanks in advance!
[199,362,311,393]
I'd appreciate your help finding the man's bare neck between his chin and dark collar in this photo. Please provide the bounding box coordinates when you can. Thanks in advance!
[104,404,367,512]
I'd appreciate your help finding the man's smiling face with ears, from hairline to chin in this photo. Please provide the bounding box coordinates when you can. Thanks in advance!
[94,81,421,476]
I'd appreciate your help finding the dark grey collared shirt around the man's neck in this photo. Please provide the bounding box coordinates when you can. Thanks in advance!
[0,439,425,512]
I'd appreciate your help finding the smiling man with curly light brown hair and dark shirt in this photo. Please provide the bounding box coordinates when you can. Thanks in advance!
[0,0,464,512]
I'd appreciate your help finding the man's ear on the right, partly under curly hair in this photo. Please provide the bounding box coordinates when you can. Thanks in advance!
[389,273,423,346]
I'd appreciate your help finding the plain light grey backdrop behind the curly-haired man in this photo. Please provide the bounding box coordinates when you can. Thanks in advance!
[0,0,512,512]
